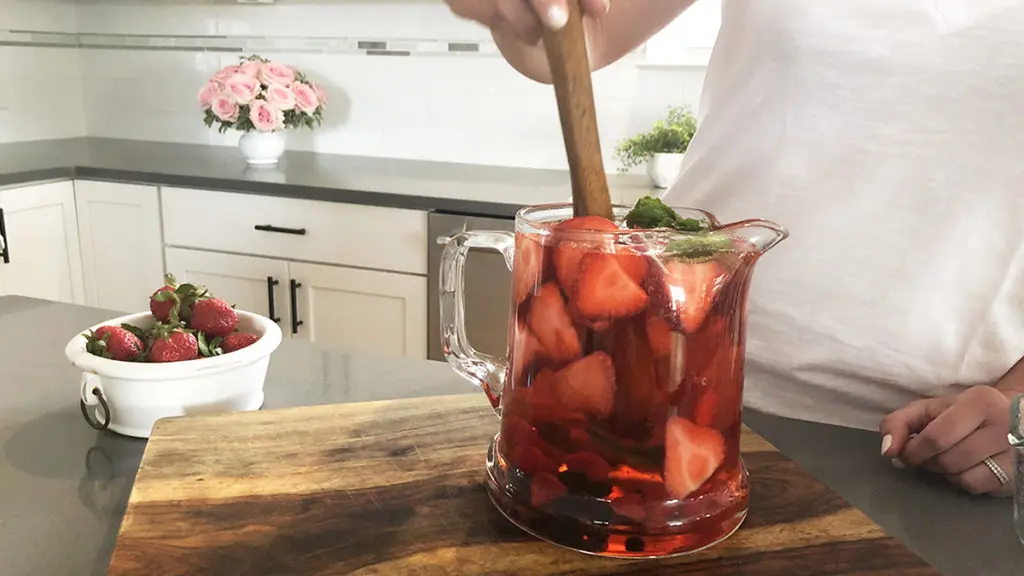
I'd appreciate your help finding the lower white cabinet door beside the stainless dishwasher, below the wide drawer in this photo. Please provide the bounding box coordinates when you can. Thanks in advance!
[285,262,427,359]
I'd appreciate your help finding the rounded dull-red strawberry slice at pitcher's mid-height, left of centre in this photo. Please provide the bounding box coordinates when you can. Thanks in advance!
[556,352,615,418]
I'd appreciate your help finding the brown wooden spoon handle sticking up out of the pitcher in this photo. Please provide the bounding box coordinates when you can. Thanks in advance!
[544,0,612,219]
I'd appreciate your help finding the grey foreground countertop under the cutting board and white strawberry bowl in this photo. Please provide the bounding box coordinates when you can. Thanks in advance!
[0,296,1024,576]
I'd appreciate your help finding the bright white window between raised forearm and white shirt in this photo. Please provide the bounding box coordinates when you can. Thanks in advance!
[643,0,722,66]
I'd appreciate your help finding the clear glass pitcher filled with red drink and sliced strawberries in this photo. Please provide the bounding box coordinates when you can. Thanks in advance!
[440,204,788,558]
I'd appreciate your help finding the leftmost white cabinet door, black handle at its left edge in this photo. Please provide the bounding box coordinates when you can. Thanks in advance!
[0,180,85,304]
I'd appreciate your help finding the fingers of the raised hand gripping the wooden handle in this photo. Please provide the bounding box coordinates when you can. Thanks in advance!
[446,0,610,45]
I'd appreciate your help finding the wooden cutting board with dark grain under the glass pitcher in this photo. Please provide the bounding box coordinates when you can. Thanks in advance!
[109,394,937,576]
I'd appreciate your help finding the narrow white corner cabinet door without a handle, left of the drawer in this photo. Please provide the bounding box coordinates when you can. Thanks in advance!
[75,180,164,313]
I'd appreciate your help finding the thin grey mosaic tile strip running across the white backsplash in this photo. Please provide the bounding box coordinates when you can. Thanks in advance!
[0,29,643,57]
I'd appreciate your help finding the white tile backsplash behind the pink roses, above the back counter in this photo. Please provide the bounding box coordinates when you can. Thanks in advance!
[0,0,703,171]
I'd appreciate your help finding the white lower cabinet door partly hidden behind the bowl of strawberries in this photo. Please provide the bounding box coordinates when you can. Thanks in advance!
[166,248,292,330]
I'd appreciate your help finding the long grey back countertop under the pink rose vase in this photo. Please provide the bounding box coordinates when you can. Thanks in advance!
[0,138,657,217]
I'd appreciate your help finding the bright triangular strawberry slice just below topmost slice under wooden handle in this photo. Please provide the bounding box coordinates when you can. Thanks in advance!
[573,253,647,319]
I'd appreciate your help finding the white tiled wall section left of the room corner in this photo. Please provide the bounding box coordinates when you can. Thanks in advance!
[0,0,85,142]
